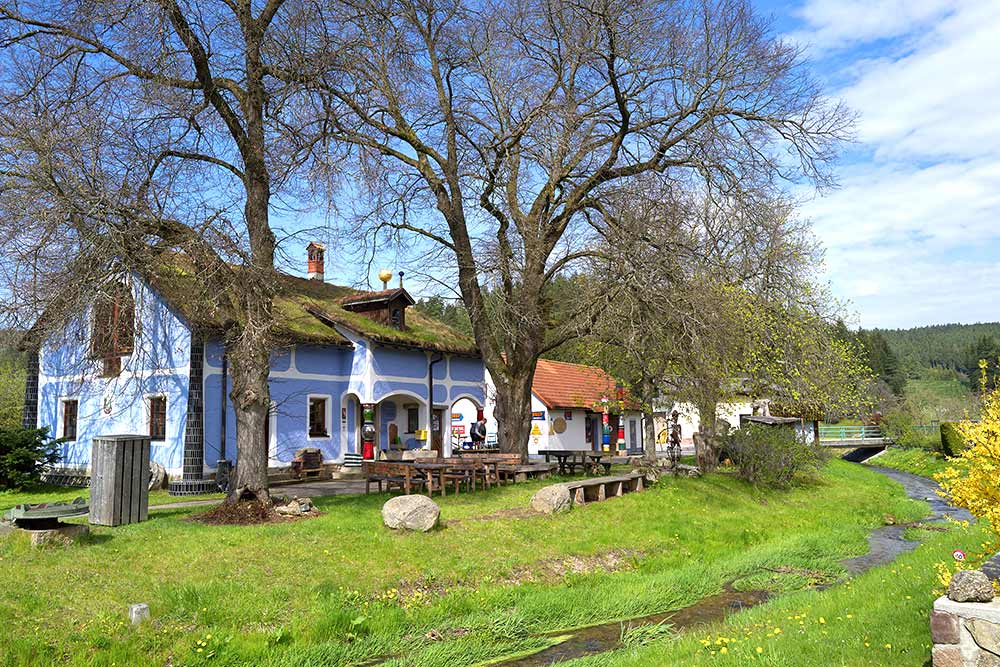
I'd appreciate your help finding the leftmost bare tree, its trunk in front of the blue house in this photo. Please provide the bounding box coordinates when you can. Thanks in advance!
[0,0,340,499]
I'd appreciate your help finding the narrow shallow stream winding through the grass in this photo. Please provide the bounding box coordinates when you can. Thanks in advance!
[496,466,972,667]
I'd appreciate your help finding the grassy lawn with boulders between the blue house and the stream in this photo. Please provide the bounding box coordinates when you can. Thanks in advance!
[0,461,960,667]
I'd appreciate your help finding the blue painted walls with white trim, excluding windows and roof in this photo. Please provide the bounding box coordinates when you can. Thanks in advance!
[39,280,485,472]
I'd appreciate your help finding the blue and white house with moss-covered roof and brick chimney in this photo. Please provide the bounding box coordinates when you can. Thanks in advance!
[24,244,485,490]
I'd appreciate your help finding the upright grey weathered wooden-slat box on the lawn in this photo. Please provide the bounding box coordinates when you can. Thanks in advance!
[90,435,149,526]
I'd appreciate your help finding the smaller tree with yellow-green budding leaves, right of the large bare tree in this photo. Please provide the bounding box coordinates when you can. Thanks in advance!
[589,183,866,469]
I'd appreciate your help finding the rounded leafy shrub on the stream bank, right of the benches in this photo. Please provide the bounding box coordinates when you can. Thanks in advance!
[724,424,827,487]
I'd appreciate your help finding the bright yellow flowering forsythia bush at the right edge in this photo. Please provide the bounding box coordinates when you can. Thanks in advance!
[936,368,1000,535]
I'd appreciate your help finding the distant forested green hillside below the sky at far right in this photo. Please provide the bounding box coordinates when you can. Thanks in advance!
[878,322,1000,377]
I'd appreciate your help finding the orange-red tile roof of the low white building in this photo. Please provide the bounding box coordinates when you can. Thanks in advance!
[531,359,634,411]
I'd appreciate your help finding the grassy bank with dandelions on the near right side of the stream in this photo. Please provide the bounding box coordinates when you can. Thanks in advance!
[568,527,984,667]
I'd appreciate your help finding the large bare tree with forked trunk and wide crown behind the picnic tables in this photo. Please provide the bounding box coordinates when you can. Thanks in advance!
[292,0,852,454]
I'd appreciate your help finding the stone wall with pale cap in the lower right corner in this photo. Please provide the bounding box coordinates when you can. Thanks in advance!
[931,596,1000,667]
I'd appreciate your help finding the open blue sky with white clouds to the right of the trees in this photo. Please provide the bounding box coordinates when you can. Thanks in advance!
[757,0,1000,327]
